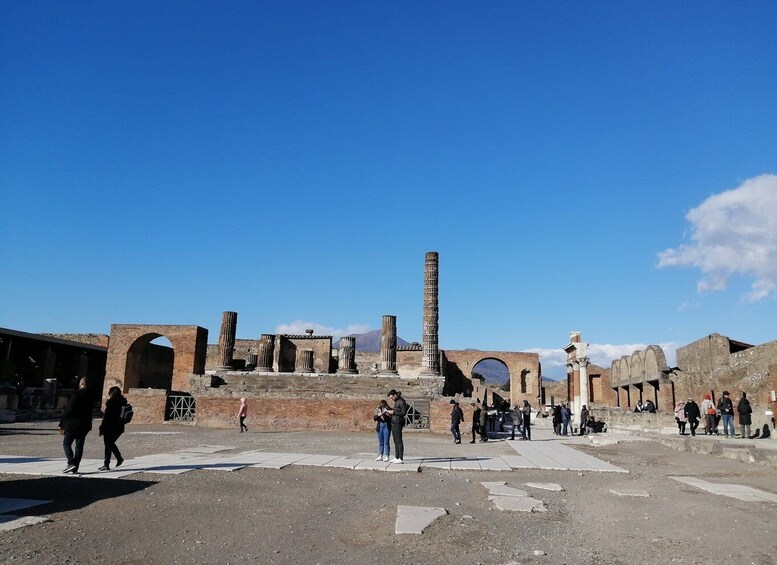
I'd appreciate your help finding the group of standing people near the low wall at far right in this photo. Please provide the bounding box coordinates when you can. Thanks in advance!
[674,390,769,439]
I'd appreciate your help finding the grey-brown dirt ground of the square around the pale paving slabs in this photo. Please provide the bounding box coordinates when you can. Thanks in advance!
[0,423,777,564]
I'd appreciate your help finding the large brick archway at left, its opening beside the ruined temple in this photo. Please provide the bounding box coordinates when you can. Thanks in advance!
[103,324,208,395]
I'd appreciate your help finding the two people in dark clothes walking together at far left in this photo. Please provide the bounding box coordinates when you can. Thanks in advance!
[59,377,127,474]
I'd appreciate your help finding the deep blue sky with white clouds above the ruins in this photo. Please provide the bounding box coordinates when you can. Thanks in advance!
[0,1,777,377]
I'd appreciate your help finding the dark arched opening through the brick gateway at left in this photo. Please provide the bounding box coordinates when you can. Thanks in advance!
[124,333,175,391]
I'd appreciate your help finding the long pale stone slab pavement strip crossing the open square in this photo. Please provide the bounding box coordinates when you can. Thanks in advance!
[0,429,628,479]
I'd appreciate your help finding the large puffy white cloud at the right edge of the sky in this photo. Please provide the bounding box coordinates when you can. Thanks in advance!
[658,175,777,302]
